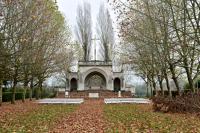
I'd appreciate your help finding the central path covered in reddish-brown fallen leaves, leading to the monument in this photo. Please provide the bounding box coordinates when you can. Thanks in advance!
[52,100,105,133]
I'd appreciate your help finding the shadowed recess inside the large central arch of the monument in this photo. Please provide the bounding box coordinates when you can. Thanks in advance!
[84,71,106,90]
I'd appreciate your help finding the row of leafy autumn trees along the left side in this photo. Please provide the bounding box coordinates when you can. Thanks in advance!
[0,0,71,104]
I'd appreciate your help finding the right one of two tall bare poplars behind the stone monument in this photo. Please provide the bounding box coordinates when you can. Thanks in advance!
[97,4,114,61]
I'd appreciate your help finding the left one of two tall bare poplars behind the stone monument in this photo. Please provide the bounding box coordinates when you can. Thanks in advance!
[75,2,92,61]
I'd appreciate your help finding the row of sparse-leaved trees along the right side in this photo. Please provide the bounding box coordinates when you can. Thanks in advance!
[110,0,200,96]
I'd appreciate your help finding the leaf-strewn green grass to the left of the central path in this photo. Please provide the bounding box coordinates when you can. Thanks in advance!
[0,105,77,133]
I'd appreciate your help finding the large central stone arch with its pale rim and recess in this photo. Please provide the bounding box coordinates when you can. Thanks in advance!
[84,68,108,89]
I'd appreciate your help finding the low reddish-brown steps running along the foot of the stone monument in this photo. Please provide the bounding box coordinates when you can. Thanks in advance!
[57,90,132,98]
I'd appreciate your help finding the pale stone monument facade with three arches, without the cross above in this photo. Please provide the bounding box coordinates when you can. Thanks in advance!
[68,61,124,91]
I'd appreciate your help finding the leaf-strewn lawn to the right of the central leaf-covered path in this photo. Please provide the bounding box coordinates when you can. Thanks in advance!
[104,104,200,133]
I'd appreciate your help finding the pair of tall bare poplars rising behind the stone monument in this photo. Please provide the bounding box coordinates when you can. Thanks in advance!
[75,2,114,62]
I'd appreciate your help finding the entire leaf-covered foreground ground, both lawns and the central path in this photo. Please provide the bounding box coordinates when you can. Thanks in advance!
[0,100,200,133]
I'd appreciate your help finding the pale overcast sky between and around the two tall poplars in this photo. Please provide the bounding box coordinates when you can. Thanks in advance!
[57,0,116,60]
